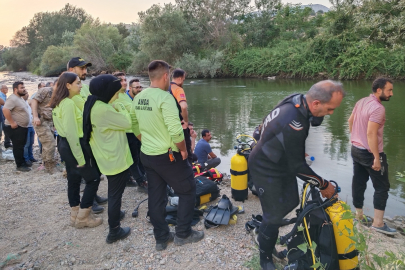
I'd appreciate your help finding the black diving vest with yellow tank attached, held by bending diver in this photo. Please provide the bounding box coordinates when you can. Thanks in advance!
[280,181,359,270]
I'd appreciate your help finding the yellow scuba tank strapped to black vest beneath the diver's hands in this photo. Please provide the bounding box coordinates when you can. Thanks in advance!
[325,201,359,270]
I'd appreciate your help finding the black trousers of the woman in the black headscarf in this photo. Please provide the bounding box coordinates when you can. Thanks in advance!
[107,170,129,229]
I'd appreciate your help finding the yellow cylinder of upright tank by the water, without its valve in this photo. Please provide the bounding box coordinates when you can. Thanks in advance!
[231,153,248,201]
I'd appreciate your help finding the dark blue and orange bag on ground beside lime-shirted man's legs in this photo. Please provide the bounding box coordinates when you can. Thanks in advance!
[194,176,220,206]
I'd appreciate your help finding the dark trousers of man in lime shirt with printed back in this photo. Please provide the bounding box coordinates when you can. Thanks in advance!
[141,152,196,243]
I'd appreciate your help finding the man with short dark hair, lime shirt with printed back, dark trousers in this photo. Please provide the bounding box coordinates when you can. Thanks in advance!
[131,60,204,251]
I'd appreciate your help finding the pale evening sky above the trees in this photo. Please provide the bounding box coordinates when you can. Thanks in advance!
[0,0,330,46]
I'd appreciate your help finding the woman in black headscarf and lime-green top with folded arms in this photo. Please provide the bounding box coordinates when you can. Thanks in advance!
[83,75,133,244]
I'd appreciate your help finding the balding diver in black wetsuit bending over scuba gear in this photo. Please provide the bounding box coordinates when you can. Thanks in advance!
[248,80,345,269]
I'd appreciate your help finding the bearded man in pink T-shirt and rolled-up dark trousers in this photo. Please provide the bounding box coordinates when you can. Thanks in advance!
[348,77,396,235]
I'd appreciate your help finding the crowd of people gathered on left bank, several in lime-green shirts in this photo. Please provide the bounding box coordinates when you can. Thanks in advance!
[2,57,220,250]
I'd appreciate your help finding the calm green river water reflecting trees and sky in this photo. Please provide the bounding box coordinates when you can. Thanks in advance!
[0,73,405,217]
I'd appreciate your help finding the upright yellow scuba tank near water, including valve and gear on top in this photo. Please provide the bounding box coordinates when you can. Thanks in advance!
[231,135,256,201]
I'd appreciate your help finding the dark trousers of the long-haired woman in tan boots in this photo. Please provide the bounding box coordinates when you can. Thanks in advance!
[58,137,101,208]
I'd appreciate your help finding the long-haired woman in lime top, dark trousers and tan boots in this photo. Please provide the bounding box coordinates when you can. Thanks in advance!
[49,72,103,228]
